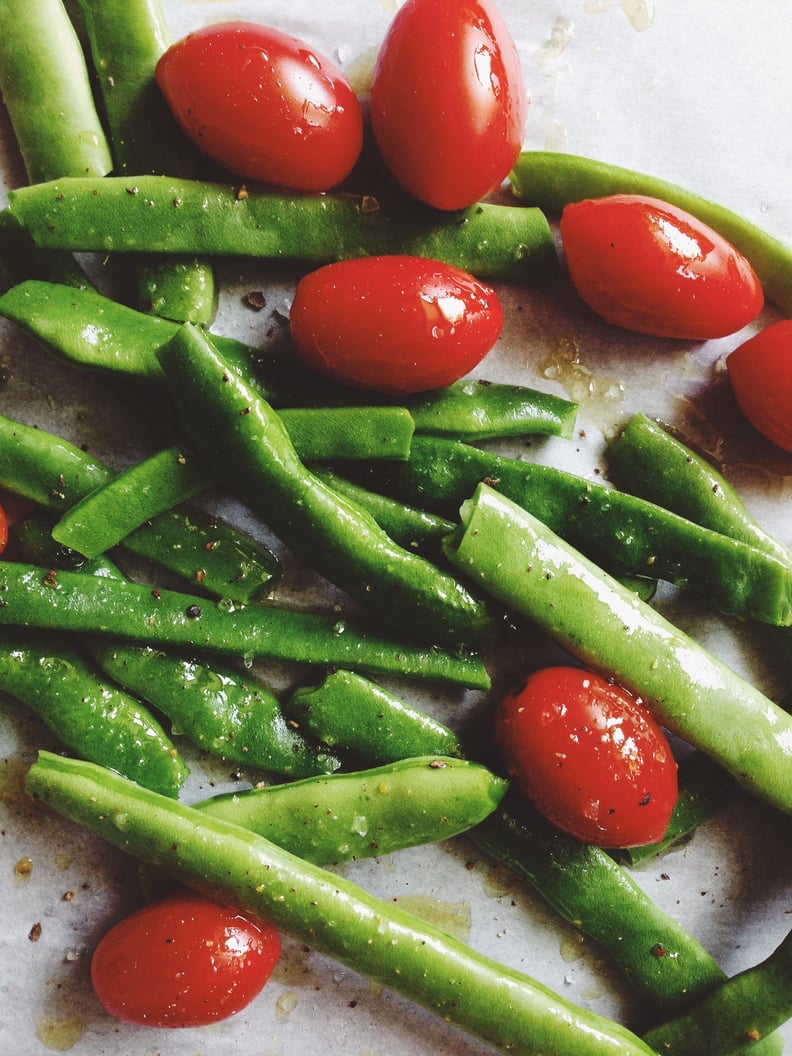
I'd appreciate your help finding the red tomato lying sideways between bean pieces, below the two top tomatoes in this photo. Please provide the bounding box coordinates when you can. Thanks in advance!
[291,257,504,394]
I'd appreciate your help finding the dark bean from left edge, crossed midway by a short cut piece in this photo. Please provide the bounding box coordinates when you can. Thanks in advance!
[0,407,279,603]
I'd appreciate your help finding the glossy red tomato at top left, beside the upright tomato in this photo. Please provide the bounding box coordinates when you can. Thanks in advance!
[156,22,363,191]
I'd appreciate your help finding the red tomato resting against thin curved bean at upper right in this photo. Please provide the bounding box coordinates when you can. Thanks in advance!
[561,194,765,340]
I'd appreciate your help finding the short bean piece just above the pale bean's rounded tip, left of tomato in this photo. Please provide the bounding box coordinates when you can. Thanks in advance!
[284,671,461,766]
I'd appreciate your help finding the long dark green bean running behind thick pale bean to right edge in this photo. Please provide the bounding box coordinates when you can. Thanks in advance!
[359,436,792,626]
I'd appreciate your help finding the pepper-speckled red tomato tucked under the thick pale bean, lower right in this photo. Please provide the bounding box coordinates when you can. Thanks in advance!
[495,666,677,847]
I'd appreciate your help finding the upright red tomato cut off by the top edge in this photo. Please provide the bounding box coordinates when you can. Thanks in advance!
[371,0,528,209]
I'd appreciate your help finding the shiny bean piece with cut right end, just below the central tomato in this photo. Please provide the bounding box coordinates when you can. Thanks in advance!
[406,379,578,441]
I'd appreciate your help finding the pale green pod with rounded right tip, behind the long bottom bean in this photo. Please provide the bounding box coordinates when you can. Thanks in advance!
[195,755,507,865]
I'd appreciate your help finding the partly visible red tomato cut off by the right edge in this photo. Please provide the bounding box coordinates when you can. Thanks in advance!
[727,319,792,451]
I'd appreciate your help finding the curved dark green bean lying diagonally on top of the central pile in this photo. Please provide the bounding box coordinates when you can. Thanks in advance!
[161,323,499,646]
